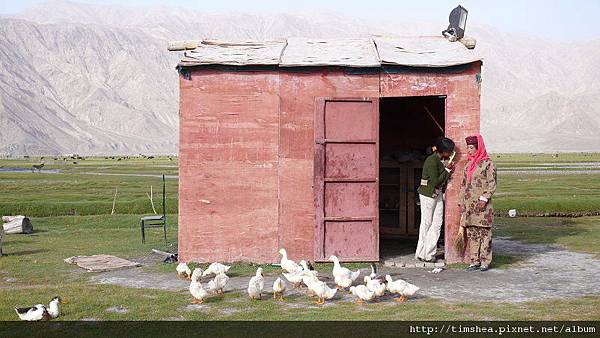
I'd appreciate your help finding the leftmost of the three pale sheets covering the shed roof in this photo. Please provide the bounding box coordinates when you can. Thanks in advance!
[180,40,285,66]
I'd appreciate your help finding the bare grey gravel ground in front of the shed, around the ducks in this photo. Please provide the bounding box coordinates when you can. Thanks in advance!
[91,238,600,304]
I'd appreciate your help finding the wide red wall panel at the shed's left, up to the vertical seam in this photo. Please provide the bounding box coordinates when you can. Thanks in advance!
[179,68,279,262]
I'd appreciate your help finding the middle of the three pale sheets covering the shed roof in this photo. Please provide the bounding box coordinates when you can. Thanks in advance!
[279,38,380,67]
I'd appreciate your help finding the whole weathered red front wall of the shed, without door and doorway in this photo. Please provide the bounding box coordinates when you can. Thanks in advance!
[179,64,480,263]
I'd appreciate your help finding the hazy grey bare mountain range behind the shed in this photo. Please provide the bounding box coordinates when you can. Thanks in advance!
[0,0,600,156]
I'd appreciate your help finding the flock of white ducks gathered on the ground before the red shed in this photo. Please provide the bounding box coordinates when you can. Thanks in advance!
[176,249,419,305]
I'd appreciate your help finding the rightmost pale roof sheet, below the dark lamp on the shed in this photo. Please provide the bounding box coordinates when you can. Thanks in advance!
[373,36,481,67]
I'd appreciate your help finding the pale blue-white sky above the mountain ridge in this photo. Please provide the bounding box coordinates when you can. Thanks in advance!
[0,0,600,41]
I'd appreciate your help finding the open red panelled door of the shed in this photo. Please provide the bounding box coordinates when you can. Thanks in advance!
[314,98,379,261]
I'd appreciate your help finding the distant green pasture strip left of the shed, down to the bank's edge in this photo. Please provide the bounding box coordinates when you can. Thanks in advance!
[0,157,178,217]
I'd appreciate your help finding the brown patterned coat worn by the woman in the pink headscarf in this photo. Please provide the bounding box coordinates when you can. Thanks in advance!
[458,160,496,228]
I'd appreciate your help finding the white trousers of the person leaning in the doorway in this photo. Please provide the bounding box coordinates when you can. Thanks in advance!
[415,194,444,260]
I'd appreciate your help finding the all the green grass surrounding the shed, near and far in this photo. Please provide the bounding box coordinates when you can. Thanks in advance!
[0,154,600,320]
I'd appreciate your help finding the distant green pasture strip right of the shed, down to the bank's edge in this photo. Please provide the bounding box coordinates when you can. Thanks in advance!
[491,153,600,216]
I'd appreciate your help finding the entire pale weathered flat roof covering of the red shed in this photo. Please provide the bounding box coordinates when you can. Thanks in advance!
[169,36,481,67]
